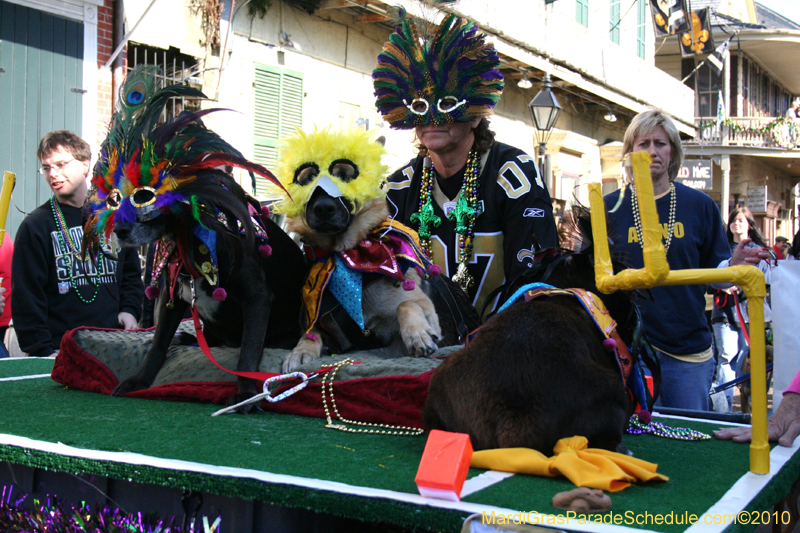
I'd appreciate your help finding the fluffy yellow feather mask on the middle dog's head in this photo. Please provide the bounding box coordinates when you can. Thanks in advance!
[275,128,388,218]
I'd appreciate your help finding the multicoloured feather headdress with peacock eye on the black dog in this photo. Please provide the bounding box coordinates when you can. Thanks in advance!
[87,65,279,243]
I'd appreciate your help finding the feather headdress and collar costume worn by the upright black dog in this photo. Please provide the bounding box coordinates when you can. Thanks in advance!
[84,66,279,301]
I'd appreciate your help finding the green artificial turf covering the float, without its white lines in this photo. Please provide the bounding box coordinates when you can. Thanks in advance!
[0,360,800,532]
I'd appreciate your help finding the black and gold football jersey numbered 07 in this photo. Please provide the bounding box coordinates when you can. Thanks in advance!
[388,143,558,312]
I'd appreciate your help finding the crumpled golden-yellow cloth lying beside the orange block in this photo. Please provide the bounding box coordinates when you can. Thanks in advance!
[470,436,669,492]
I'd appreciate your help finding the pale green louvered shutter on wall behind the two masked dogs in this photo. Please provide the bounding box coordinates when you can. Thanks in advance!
[253,65,303,198]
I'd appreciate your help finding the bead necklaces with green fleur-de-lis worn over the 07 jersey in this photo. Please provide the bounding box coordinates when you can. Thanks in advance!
[411,148,480,292]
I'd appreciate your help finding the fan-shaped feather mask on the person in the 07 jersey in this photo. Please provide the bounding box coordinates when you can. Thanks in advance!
[372,15,504,129]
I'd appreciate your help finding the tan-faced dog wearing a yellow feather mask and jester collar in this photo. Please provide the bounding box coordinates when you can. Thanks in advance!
[276,129,479,372]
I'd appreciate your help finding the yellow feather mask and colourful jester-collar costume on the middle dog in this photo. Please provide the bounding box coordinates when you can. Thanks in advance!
[276,129,438,351]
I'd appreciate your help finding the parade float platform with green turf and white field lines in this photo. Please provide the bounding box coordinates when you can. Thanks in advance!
[0,350,800,532]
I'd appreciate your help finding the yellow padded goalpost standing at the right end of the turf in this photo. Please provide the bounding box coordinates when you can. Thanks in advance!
[589,152,769,474]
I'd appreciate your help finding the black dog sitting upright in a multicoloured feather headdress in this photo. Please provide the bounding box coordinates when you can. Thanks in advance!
[84,66,305,412]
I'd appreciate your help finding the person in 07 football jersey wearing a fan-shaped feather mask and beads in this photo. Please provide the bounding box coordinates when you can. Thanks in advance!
[372,15,557,310]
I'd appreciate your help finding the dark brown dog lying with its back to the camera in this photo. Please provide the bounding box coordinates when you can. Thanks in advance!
[423,243,638,455]
